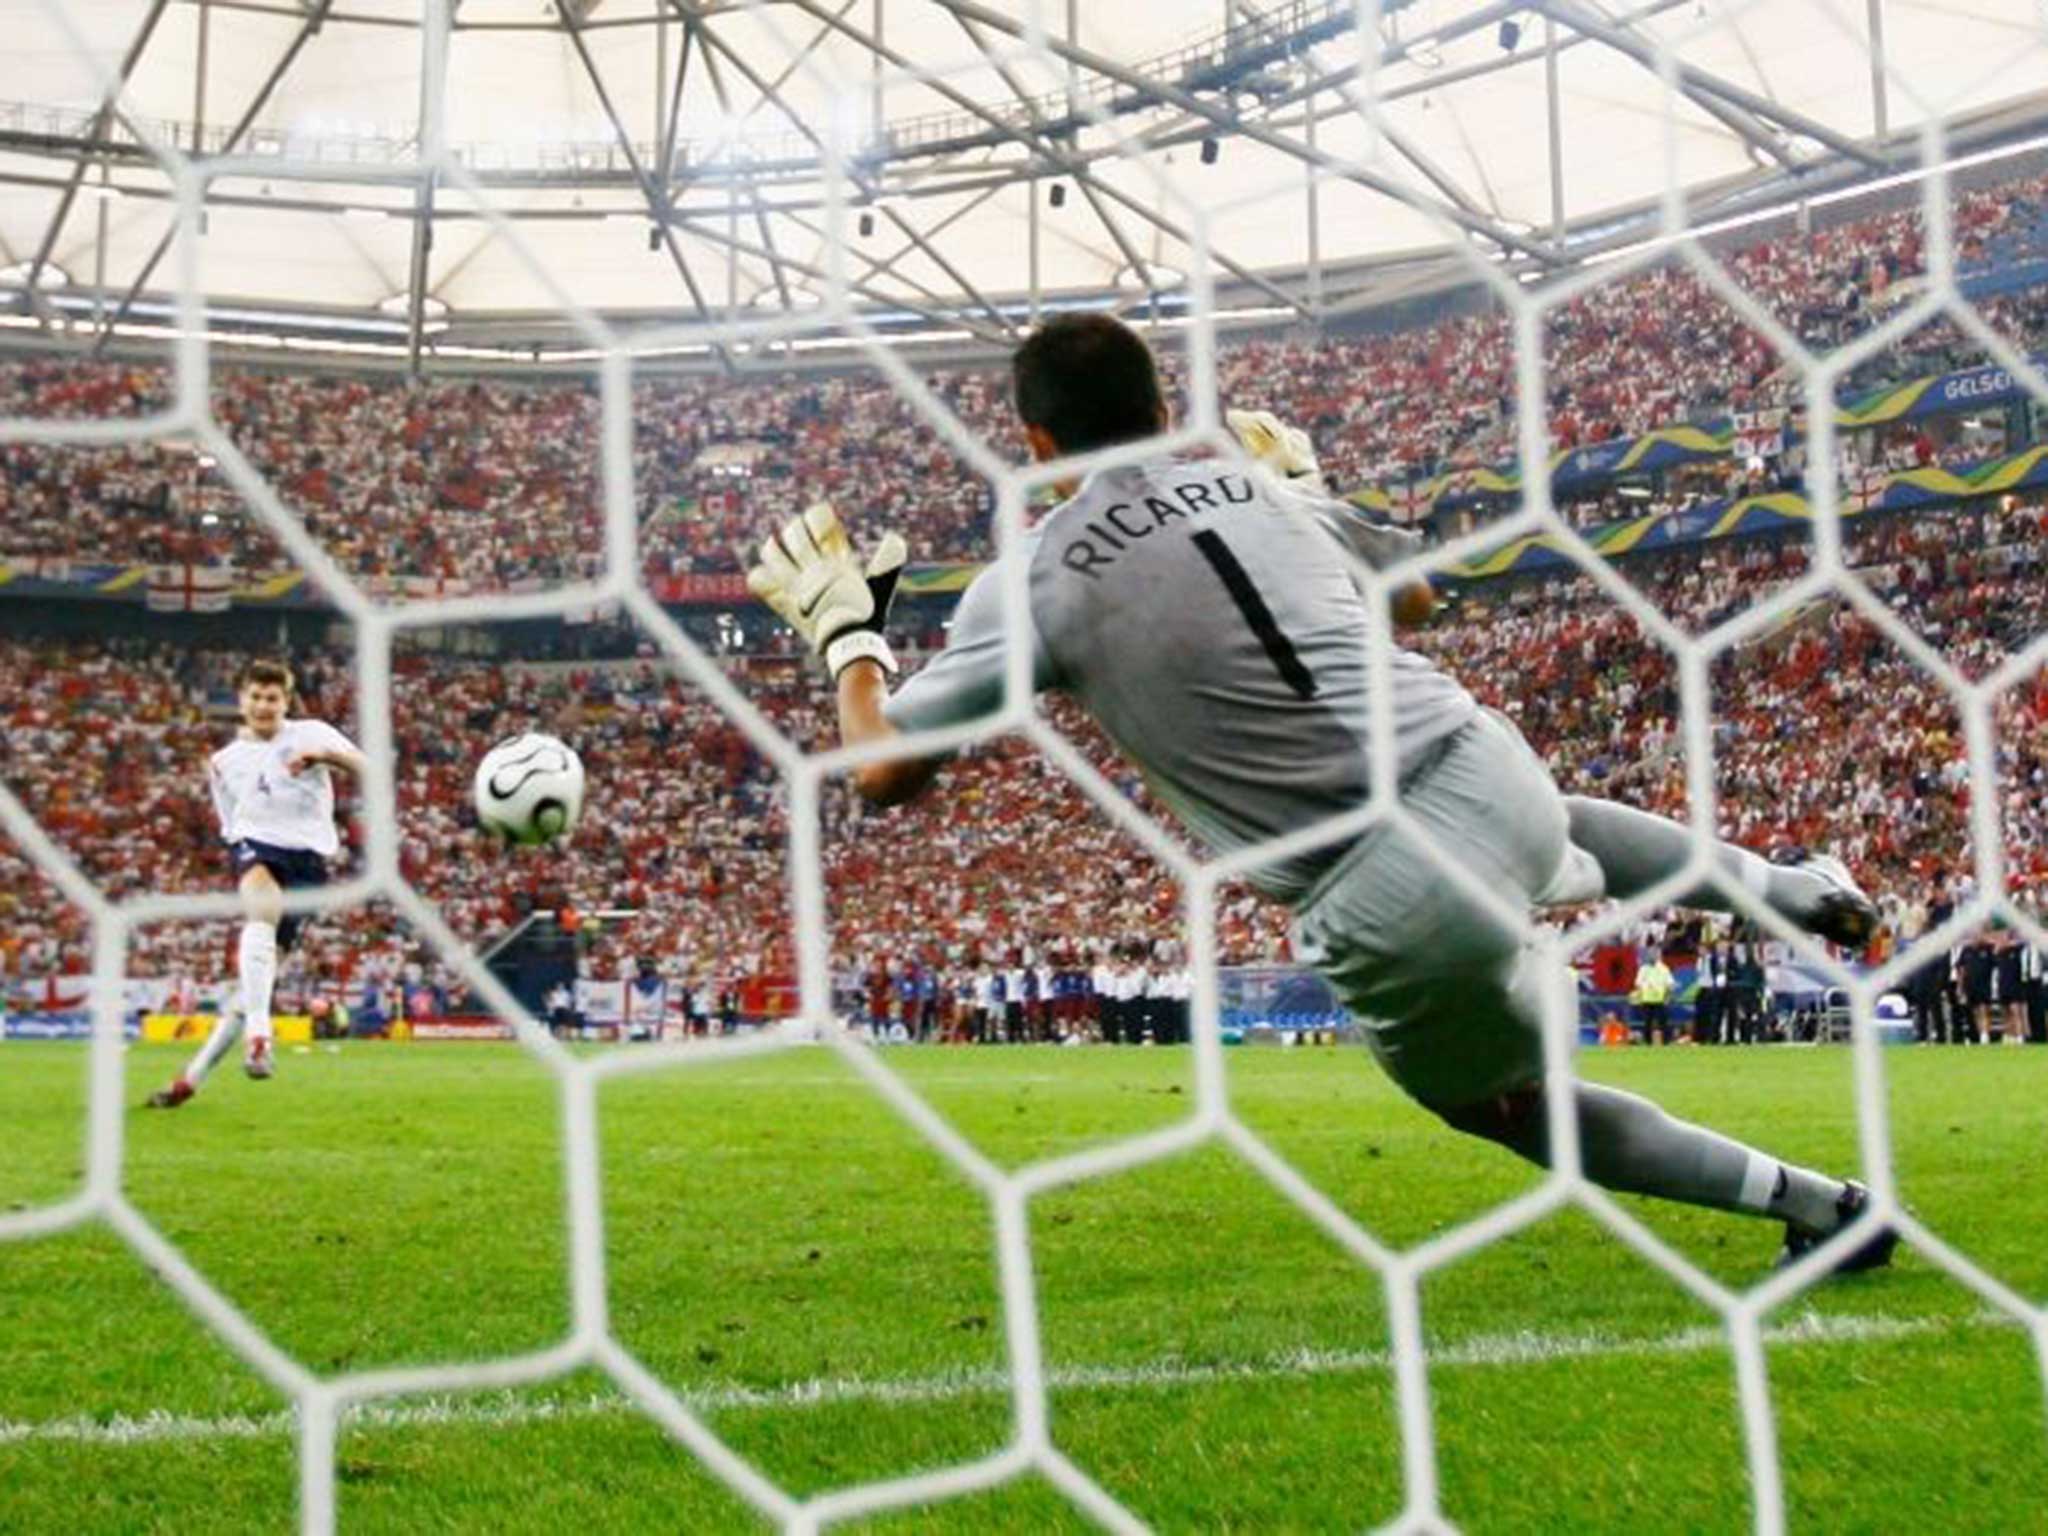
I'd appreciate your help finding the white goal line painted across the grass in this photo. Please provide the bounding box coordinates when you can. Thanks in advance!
[0,1313,2017,1446]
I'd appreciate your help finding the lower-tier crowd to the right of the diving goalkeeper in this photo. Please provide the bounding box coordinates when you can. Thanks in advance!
[1417,504,2048,930]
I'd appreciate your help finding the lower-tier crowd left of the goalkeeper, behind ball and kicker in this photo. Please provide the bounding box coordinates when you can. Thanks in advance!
[0,626,1220,1024]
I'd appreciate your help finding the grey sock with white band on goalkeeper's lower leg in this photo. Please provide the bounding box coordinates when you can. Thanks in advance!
[1450,1083,1843,1233]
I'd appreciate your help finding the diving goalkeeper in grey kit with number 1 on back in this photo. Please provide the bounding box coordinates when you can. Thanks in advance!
[748,315,1896,1268]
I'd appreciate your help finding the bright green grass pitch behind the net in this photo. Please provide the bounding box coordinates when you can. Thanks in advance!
[0,1042,2048,1532]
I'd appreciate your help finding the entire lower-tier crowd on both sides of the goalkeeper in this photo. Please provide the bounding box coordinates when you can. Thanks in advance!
[0,493,2048,999]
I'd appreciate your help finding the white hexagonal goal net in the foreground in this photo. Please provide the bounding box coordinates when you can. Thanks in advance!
[0,0,2048,1532]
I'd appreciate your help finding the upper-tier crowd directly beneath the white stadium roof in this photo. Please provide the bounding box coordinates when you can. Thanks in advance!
[12,162,2048,590]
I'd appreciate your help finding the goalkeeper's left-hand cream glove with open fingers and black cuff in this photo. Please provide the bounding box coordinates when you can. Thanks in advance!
[748,502,907,678]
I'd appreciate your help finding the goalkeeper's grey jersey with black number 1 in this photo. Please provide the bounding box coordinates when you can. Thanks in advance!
[889,457,1477,901]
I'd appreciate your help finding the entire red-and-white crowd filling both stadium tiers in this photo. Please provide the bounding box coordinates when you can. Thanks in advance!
[0,162,2048,1036]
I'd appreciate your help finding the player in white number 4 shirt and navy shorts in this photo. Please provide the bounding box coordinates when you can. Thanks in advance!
[150,662,362,1110]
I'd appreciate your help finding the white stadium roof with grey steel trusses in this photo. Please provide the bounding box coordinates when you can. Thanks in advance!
[0,0,2048,364]
